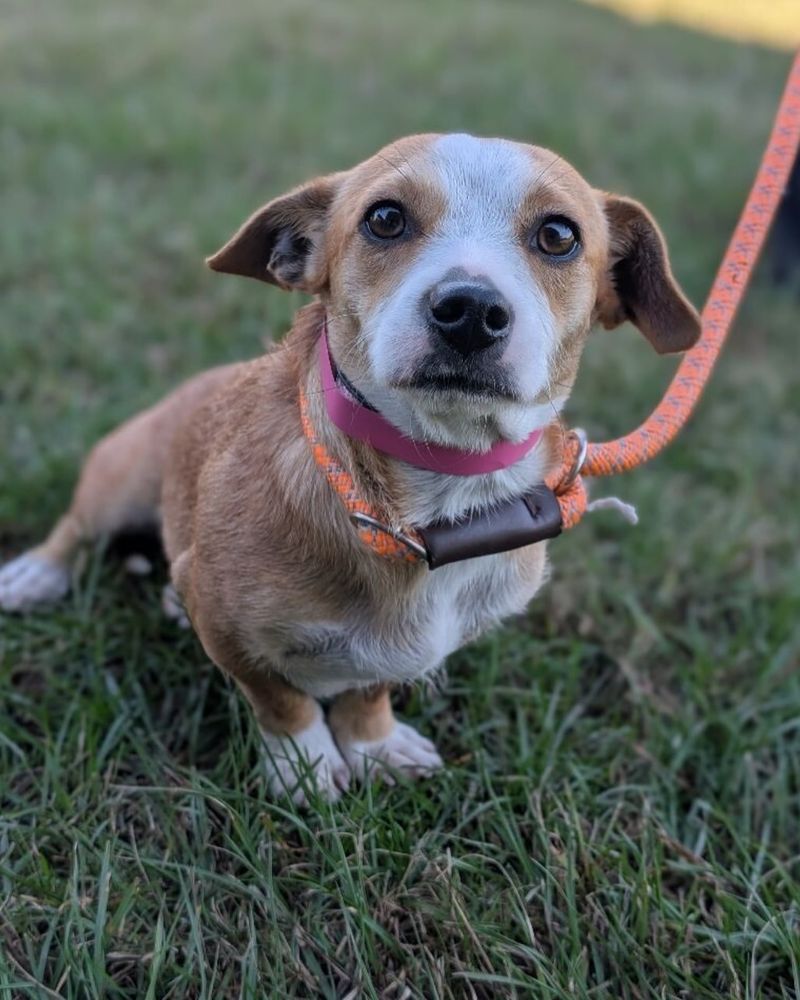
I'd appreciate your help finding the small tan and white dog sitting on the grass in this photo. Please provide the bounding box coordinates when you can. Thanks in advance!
[0,135,699,802]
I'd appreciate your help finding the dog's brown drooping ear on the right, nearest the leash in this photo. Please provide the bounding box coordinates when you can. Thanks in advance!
[597,195,700,354]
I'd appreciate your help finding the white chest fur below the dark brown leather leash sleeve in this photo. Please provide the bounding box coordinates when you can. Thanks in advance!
[269,546,545,697]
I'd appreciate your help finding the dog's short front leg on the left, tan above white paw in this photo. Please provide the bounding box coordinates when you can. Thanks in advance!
[235,669,350,805]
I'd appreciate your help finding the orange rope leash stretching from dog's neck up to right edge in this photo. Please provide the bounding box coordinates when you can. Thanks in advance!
[547,52,800,528]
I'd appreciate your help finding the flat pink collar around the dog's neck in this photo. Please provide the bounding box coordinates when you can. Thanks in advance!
[319,326,542,476]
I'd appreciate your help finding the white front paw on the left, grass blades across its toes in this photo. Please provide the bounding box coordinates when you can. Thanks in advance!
[261,709,350,806]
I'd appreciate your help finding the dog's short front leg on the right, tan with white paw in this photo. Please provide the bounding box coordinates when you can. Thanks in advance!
[329,684,443,784]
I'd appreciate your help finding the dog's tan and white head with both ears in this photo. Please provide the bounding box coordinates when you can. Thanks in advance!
[209,135,700,450]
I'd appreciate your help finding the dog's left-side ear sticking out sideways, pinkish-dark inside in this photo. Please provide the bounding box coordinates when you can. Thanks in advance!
[206,175,339,292]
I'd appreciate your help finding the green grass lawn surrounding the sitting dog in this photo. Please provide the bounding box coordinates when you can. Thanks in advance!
[0,0,800,1000]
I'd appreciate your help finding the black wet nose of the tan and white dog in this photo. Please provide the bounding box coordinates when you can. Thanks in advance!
[428,281,511,355]
